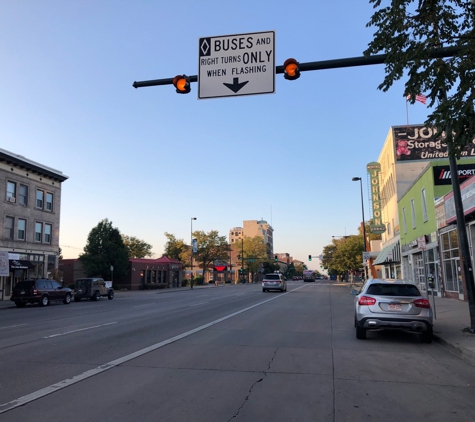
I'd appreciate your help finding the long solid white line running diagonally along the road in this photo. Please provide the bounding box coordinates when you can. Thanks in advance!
[0,286,305,415]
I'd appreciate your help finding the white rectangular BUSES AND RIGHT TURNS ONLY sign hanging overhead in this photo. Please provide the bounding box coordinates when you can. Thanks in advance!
[198,31,275,99]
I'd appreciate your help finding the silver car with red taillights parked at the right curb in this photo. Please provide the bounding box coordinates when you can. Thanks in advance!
[355,279,433,343]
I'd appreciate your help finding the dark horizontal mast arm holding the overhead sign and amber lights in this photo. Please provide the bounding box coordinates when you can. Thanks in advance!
[132,47,466,88]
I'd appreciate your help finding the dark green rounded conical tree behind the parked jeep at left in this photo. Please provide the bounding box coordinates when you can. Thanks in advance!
[79,218,129,280]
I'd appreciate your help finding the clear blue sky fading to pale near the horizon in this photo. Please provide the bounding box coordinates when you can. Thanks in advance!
[0,0,431,269]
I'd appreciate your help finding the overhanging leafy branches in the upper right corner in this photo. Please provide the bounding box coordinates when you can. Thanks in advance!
[364,0,475,158]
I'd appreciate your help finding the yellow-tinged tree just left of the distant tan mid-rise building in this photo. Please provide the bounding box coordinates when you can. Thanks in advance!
[193,230,230,274]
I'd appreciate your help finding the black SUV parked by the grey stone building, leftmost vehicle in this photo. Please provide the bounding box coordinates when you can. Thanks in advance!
[10,278,72,308]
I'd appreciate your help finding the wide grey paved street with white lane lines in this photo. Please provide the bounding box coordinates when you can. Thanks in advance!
[0,281,475,422]
